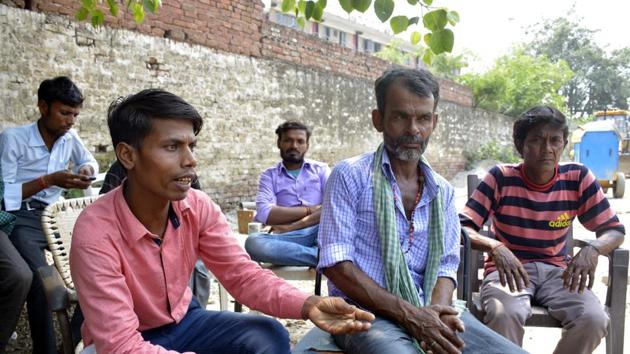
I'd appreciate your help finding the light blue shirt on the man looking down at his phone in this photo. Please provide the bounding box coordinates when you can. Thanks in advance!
[0,122,98,211]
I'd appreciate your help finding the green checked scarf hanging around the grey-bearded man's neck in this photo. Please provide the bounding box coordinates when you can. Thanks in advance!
[372,144,444,352]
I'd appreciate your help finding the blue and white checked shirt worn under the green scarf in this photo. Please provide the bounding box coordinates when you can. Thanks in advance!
[318,151,460,304]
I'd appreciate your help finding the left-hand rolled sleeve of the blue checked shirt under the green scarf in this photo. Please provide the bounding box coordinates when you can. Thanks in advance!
[318,163,357,269]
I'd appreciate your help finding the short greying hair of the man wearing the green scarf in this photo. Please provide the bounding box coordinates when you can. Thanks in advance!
[374,68,440,115]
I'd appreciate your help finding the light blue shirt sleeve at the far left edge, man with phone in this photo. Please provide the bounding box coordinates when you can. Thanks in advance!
[0,132,22,211]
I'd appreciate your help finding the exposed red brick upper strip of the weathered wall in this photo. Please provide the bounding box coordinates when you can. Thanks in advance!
[0,0,473,106]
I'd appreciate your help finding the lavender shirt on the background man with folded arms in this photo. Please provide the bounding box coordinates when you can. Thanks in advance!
[256,160,330,224]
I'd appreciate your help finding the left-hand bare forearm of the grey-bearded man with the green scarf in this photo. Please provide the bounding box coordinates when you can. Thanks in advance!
[324,261,413,323]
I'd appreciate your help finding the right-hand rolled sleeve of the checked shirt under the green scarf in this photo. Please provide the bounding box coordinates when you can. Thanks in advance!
[438,186,461,287]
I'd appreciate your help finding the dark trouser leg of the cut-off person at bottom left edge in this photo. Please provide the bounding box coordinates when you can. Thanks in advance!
[0,231,33,353]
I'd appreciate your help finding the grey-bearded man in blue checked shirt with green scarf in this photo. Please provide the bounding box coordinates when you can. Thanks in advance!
[318,69,523,354]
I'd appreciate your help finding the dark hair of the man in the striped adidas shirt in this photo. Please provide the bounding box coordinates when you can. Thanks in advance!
[512,106,569,153]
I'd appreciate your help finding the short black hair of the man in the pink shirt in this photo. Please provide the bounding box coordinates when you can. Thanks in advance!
[107,89,203,149]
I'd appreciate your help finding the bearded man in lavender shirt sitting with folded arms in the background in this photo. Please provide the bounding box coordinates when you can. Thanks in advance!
[245,121,330,267]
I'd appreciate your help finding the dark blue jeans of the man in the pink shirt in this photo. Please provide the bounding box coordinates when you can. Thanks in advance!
[142,298,291,354]
